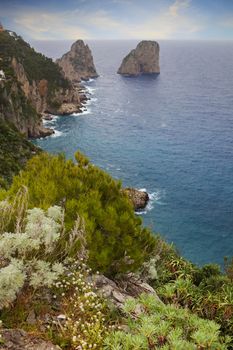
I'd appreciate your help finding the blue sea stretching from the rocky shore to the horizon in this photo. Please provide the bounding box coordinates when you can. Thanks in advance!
[34,40,233,266]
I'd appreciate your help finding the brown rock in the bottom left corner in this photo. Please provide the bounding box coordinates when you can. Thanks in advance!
[0,329,61,350]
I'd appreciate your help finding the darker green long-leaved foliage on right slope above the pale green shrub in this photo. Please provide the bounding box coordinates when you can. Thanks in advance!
[142,237,233,346]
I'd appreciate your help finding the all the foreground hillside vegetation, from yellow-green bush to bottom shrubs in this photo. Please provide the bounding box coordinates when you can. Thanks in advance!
[0,151,233,350]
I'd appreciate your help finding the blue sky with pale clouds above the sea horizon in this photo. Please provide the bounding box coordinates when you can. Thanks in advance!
[0,0,233,40]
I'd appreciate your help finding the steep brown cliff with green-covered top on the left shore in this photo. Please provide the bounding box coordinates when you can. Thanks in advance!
[0,31,81,137]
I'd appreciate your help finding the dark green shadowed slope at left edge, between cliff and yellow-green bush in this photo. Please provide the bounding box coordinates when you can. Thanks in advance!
[0,119,40,188]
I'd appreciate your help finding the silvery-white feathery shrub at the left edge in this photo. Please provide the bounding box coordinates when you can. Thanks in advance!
[0,203,63,309]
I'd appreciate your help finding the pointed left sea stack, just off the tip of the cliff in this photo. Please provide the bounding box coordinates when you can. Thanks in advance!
[56,40,98,82]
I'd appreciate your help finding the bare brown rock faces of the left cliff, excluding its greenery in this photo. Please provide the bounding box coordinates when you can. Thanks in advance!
[9,57,85,138]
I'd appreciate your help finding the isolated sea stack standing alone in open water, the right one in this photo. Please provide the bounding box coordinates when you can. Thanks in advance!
[117,40,160,76]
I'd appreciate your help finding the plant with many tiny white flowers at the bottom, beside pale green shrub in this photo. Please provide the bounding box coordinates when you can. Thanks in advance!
[49,260,113,350]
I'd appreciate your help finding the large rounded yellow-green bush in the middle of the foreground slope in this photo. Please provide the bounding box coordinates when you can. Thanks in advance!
[4,153,154,275]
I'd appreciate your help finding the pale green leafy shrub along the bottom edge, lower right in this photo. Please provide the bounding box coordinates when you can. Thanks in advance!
[105,294,229,350]
